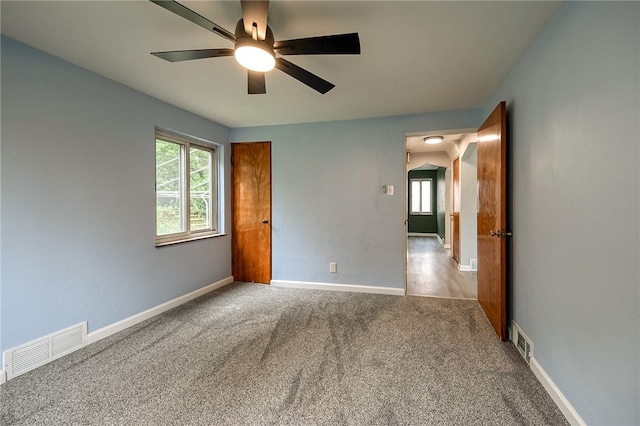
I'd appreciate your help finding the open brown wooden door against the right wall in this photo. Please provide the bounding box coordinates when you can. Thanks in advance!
[478,102,510,340]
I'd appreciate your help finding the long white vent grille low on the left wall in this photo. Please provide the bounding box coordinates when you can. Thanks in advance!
[3,321,87,380]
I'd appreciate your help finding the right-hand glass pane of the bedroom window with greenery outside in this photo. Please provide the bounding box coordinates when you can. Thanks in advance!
[189,148,211,231]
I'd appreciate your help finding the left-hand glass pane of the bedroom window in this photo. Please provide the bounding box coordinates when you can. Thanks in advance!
[156,139,184,235]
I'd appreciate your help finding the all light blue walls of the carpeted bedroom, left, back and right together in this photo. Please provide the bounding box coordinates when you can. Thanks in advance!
[5,2,640,424]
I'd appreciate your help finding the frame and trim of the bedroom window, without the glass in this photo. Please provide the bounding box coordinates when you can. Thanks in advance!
[154,127,224,247]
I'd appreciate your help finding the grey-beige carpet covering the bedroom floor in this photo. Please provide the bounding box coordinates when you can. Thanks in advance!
[0,283,566,425]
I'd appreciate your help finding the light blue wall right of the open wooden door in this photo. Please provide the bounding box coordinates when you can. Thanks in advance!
[487,2,640,425]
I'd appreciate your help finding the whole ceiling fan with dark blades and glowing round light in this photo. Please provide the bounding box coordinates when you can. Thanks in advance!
[150,0,360,95]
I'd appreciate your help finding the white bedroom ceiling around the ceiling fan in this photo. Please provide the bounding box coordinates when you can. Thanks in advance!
[1,0,560,127]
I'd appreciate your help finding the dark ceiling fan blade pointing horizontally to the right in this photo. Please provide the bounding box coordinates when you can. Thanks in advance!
[273,33,360,55]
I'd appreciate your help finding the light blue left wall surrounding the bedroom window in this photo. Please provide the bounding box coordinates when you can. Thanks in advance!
[0,37,231,350]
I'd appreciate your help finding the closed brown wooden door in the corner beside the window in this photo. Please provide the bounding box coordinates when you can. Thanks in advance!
[231,142,271,284]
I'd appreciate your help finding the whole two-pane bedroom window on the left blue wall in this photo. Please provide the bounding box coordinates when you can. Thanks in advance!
[156,129,219,245]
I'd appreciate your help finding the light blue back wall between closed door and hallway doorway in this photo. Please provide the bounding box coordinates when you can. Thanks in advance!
[231,110,482,288]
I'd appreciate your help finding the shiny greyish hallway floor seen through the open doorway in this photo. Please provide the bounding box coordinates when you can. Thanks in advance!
[407,237,478,299]
